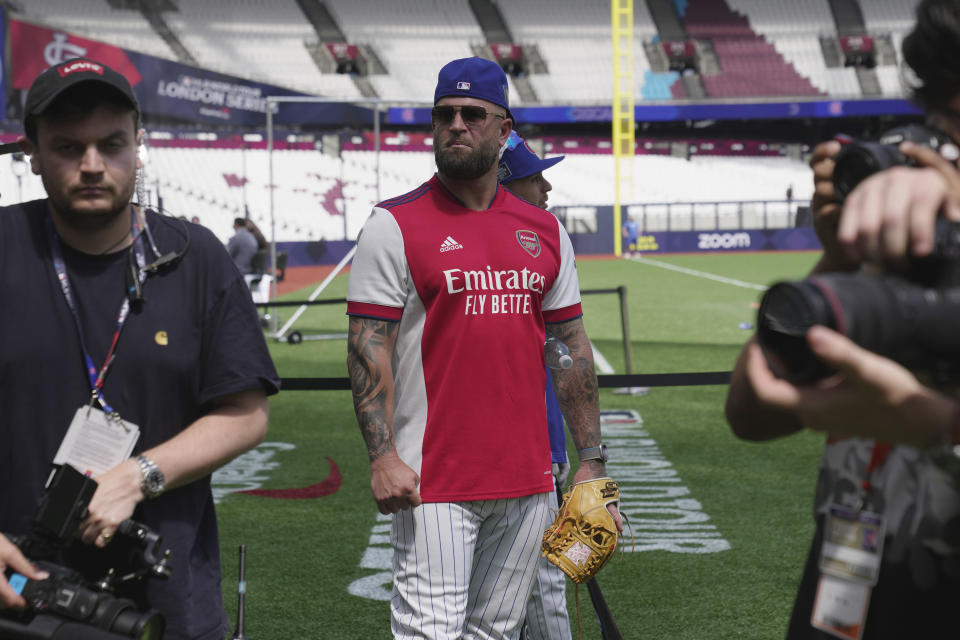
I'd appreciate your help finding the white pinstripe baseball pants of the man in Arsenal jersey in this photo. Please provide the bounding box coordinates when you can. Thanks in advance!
[390,493,552,640]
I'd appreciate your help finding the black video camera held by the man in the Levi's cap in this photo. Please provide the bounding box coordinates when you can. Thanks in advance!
[0,465,170,640]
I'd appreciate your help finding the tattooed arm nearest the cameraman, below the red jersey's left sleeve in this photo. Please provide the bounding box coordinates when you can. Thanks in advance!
[347,317,400,460]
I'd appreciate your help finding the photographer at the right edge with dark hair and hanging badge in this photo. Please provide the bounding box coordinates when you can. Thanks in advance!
[726,0,960,640]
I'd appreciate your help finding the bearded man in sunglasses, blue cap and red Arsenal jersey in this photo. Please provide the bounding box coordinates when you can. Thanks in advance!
[347,58,622,640]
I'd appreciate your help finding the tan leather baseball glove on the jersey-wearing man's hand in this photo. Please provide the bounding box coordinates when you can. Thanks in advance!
[542,478,620,583]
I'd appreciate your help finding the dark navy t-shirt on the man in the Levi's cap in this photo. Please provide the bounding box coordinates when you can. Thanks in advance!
[0,200,279,640]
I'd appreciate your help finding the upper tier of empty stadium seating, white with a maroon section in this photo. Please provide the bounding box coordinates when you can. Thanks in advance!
[7,0,916,104]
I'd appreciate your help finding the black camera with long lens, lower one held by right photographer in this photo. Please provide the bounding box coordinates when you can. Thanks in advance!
[757,220,960,384]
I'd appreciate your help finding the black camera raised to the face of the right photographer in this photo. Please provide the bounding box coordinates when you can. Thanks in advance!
[833,124,960,202]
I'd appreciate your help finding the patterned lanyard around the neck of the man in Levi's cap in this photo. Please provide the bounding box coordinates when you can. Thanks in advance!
[47,206,147,414]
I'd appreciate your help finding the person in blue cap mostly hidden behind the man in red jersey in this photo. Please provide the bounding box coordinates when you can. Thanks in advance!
[497,131,572,640]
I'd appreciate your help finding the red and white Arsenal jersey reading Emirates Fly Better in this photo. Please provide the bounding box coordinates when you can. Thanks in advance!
[347,176,581,502]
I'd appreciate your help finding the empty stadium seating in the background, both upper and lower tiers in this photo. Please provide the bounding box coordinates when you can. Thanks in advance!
[0,0,928,254]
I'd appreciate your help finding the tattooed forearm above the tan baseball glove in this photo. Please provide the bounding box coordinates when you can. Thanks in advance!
[547,318,600,449]
